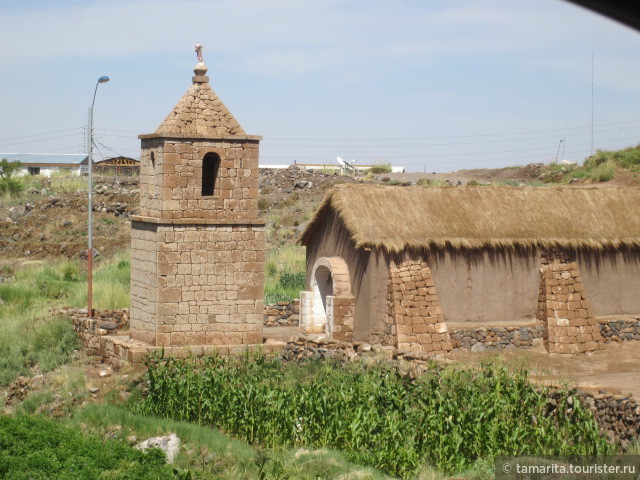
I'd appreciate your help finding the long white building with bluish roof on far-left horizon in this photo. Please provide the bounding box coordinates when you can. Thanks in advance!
[0,153,88,177]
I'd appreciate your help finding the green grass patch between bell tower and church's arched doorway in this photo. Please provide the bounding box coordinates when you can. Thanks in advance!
[264,245,306,303]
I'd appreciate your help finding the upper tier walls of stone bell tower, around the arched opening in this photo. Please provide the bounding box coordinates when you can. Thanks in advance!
[140,137,259,221]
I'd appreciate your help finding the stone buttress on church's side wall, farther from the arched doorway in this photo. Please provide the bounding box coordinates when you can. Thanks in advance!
[536,253,603,354]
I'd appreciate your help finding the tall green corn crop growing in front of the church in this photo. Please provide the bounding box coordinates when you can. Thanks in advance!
[134,355,613,478]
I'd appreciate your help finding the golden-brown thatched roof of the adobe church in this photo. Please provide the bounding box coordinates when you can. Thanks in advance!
[300,185,640,252]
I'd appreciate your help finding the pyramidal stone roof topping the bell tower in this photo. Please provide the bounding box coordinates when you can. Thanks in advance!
[155,62,246,138]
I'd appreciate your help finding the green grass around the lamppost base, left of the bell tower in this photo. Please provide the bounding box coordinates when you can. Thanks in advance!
[0,253,130,385]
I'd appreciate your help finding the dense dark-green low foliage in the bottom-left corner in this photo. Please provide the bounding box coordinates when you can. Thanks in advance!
[0,415,181,480]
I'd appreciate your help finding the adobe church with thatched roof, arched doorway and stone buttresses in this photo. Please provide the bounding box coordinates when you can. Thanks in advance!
[300,185,640,353]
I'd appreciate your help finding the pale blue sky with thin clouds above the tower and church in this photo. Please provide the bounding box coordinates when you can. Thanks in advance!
[0,0,640,171]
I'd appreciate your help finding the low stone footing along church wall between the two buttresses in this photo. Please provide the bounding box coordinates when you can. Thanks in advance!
[449,325,544,352]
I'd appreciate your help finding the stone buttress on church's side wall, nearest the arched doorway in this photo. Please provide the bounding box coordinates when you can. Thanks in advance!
[386,260,453,352]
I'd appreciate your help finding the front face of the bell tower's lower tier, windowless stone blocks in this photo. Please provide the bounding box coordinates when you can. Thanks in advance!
[156,225,265,345]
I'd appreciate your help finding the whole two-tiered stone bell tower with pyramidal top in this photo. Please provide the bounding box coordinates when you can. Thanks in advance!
[130,44,265,346]
